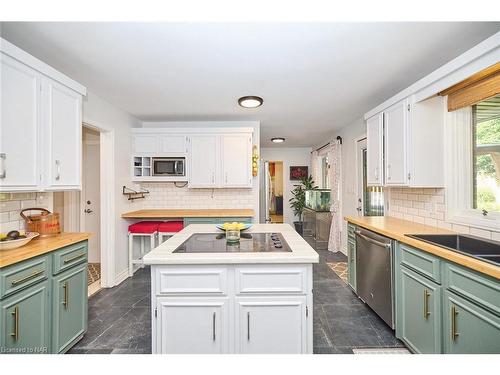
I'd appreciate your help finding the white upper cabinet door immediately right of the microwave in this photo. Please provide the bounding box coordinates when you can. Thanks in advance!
[189,135,220,188]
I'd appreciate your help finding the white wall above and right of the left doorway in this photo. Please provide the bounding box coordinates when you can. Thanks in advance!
[83,91,141,284]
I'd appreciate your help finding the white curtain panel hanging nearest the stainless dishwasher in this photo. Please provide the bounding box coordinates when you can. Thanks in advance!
[328,142,342,253]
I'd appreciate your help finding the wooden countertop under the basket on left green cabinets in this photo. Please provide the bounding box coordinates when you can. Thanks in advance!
[0,233,91,268]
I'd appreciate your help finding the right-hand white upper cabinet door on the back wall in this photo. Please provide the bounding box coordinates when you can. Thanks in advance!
[221,134,252,188]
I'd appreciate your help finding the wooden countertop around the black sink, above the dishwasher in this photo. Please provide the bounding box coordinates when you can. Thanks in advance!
[344,216,500,279]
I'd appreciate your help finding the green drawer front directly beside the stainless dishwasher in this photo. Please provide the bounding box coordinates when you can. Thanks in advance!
[399,243,441,284]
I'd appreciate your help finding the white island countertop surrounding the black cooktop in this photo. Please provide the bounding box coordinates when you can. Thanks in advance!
[144,224,319,265]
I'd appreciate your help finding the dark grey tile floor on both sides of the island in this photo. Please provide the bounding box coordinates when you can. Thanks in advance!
[68,250,403,354]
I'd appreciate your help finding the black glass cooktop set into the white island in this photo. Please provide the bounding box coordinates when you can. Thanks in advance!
[174,232,292,253]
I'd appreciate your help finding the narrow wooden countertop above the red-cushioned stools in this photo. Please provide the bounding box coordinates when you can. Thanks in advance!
[122,208,254,219]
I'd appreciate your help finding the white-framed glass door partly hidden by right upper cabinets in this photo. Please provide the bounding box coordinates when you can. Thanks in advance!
[356,138,384,216]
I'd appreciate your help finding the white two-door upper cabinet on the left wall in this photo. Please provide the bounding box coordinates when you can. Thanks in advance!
[0,39,86,192]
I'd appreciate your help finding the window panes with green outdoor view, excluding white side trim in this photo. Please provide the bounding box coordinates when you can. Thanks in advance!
[472,96,500,215]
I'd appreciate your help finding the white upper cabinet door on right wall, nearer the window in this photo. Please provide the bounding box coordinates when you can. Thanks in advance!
[384,100,409,186]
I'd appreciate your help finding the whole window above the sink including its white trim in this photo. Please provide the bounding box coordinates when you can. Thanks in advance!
[445,96,500,231]
